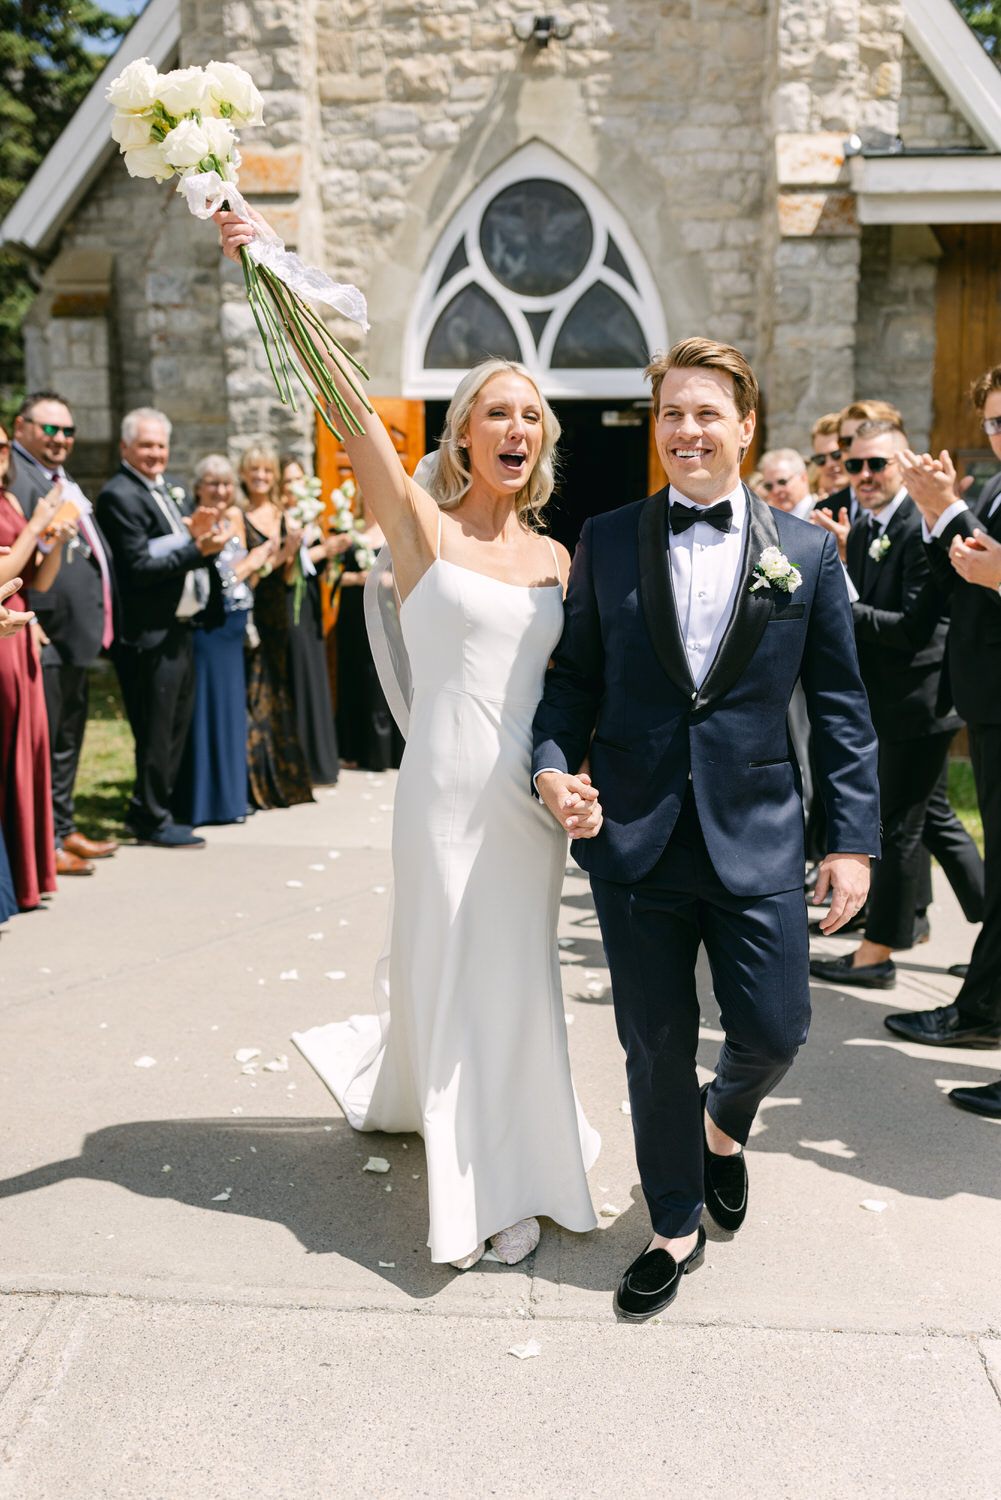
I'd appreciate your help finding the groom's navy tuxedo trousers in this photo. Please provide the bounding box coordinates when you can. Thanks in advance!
[591,785,810,1238]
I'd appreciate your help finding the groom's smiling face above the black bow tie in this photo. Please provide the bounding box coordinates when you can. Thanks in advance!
[656,368,755,506]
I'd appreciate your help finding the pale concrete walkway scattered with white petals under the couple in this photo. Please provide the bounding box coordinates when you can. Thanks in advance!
[0,773,1001,1500]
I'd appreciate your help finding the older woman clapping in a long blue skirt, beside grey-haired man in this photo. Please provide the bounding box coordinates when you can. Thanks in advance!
[171,453,276,827]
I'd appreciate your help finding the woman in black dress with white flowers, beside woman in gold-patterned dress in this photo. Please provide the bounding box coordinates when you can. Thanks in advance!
[279,453,350,786]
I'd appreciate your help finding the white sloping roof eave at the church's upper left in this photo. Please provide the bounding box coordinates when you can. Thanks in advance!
[0,0,180,254]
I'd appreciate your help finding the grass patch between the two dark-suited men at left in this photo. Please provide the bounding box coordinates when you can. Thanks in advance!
[75,660,135,839]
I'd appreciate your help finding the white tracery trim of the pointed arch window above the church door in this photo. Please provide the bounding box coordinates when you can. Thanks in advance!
[402,141,668,401]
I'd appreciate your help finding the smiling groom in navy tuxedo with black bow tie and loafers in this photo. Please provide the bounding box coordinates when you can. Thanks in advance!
[533,339,879,1322]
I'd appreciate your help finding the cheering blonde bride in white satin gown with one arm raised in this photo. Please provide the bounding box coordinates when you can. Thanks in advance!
[216,213,602,1269]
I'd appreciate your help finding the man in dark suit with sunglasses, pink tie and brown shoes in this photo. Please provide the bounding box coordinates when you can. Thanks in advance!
[11,390,119,875]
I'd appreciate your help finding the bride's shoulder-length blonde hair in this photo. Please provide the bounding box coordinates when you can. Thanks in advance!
[414,360,560,531]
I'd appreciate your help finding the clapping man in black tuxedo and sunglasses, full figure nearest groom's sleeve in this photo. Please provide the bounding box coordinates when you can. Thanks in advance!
[810,422,981,990]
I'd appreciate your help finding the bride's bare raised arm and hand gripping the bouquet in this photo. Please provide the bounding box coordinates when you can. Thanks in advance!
[213,209,438,597]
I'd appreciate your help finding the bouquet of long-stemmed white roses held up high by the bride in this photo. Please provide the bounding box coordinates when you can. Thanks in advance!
[107,57,372,438]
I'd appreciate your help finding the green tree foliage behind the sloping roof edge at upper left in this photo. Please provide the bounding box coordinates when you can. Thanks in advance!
[0,0,132,416]
